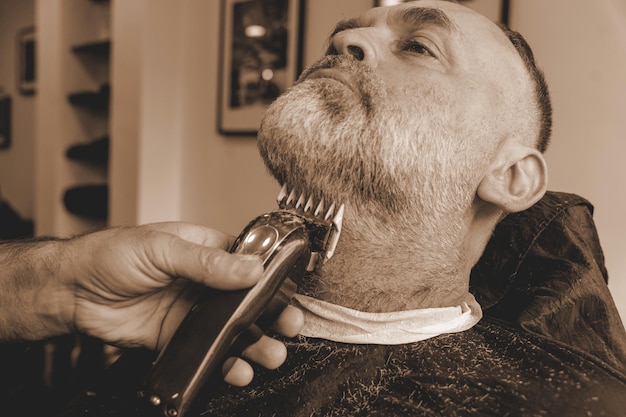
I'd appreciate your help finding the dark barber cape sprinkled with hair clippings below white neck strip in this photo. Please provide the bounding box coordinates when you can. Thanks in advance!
[195,318,626,417]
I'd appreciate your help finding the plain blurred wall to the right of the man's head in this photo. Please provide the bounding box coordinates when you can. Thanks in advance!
[511,0,626,320]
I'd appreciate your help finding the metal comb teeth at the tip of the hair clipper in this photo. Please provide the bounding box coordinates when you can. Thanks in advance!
[276,184,345,262]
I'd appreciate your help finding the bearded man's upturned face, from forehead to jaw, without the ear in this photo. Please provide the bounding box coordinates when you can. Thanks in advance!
[259,1,530,231]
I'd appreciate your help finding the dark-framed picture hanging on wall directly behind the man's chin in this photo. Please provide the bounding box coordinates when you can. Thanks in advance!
[218,0,303,136]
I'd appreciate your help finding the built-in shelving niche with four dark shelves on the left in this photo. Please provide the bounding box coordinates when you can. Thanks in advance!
[35,0,112,235]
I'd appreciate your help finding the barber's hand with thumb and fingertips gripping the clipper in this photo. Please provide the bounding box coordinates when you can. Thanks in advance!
[65,222,303,385]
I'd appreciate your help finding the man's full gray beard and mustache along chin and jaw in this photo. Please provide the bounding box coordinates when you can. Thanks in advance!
[258,56,475,223]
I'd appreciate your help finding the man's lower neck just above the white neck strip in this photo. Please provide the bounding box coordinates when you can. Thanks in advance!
[300,231,470,312]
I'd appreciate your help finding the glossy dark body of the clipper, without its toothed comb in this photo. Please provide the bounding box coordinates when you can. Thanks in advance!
[144,213,310,417]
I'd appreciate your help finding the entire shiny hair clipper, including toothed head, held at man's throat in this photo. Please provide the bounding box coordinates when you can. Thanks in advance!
[140,186,343,417]
